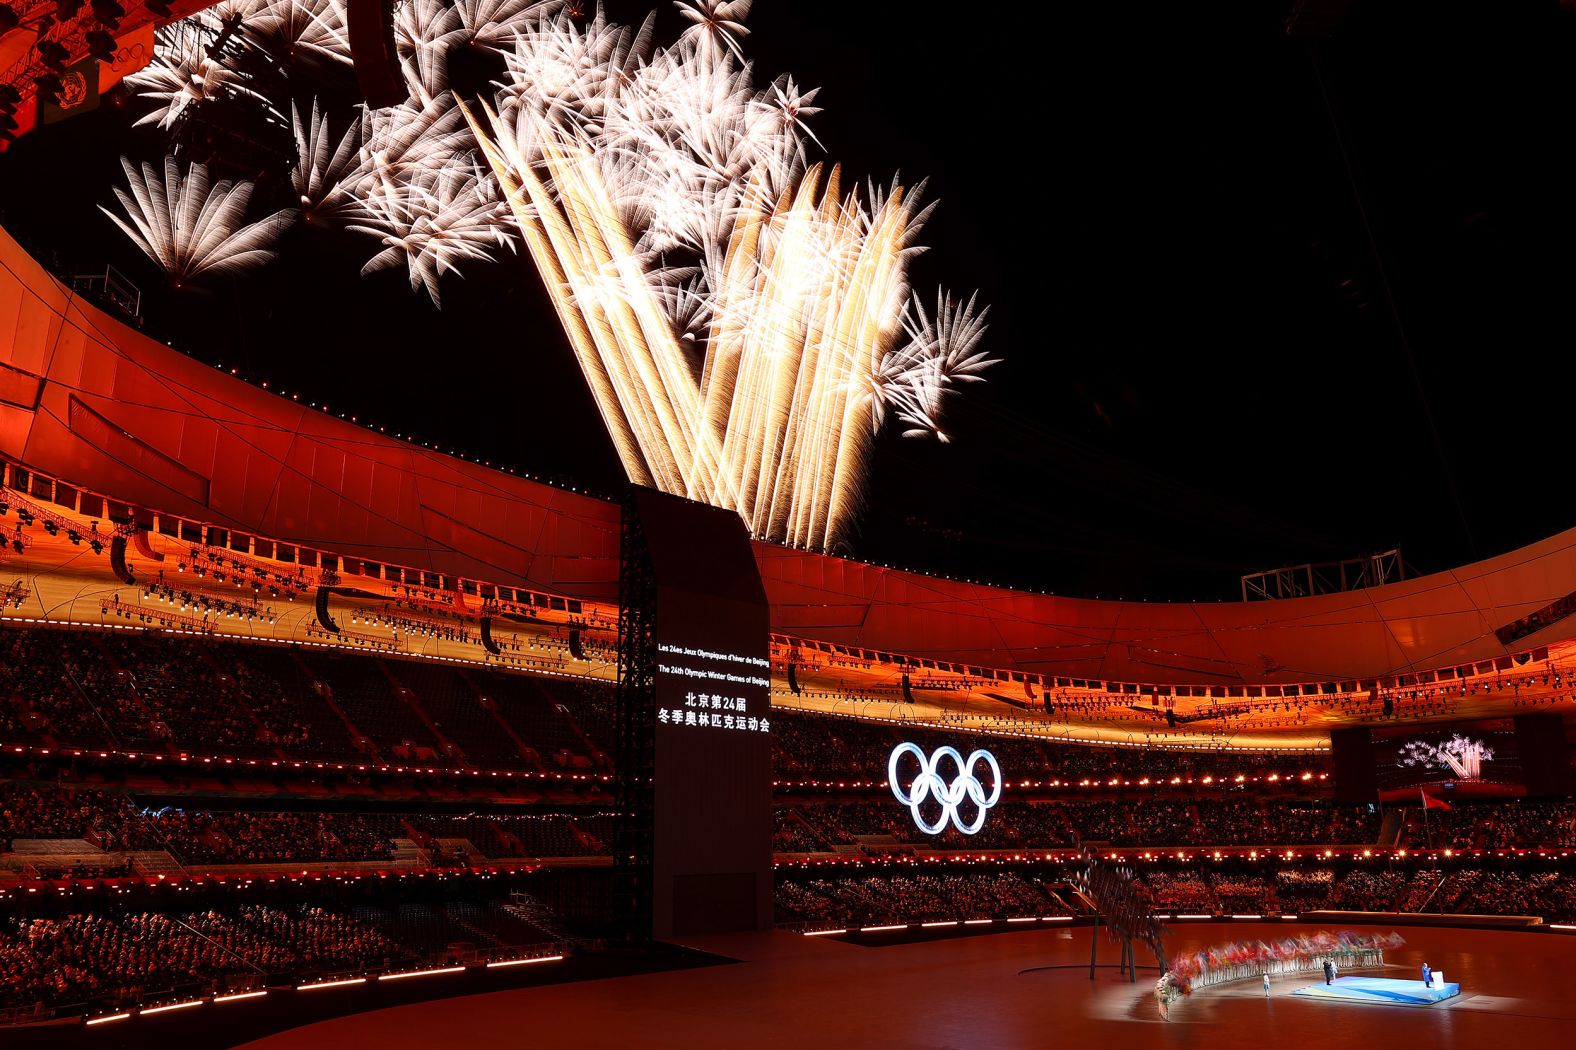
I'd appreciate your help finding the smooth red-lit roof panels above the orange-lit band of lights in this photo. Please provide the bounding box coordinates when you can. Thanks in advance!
[9,222,1576,687]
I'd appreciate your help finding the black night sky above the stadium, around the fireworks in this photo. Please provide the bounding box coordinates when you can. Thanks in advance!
[0,0,1576,599]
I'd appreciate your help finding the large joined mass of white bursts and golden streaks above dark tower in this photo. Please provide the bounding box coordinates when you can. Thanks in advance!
[128,0,994,549]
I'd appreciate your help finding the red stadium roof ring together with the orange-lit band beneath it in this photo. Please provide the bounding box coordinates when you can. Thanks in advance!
[0,219,1576,747]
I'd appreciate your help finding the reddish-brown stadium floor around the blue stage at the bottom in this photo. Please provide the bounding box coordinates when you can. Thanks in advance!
[244,922,1576,1050]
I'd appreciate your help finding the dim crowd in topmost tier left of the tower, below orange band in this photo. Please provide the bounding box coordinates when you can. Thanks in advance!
[0,629,611,769]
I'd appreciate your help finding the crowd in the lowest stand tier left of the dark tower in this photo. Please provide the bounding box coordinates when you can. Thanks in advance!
[0,872,576,1020]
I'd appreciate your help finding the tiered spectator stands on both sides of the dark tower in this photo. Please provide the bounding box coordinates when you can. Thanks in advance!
[0,626,1576,1014]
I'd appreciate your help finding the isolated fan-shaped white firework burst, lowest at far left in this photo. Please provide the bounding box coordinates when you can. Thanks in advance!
[99,156,295,284]
